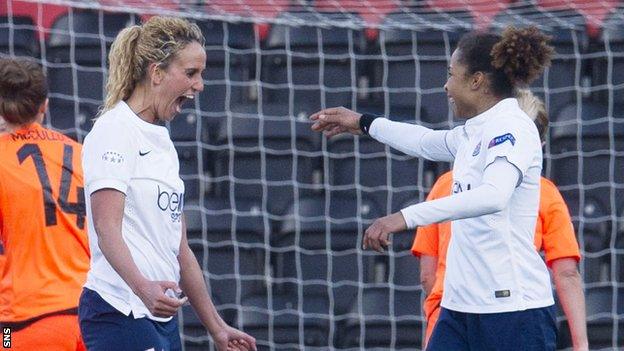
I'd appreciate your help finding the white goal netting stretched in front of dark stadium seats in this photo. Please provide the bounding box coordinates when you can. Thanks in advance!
[0,0,624,350]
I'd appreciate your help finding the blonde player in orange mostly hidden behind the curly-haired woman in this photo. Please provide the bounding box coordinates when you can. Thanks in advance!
[412,90,588,351]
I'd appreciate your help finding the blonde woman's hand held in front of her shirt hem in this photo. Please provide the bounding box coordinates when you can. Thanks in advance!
[137,280,188,318]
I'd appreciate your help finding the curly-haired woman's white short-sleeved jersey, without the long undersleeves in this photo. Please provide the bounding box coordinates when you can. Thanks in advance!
[442,99,554,313]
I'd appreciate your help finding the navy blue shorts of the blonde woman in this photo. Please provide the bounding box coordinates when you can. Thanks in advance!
[78,288,182,351]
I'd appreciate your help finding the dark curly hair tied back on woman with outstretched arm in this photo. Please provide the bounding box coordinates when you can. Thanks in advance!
[457,26,555,97]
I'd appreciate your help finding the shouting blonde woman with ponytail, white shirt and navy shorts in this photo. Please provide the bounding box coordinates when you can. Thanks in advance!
[79,17,255,350]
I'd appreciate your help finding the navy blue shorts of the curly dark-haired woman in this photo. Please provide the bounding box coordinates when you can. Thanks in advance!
[427,306,557,351]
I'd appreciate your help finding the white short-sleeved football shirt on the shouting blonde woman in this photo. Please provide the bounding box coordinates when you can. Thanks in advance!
[82,102,184,321]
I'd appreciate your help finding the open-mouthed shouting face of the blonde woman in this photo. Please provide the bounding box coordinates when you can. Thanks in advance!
[152,42,206,122]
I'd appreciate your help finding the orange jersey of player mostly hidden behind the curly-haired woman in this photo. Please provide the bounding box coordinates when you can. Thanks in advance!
[412,172,581,346]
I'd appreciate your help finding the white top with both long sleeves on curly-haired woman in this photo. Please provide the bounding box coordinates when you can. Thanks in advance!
[369,99,554,313]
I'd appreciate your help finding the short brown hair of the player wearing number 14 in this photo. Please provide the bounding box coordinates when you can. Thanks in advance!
[0,59,48,124]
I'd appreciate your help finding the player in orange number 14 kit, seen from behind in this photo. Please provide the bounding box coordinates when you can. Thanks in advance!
[0,59,89,351]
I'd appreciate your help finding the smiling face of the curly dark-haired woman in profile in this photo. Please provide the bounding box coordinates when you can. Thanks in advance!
[444,50,478,119]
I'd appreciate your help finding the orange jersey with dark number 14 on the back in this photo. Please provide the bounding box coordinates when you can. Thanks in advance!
[0,123,89,322]
